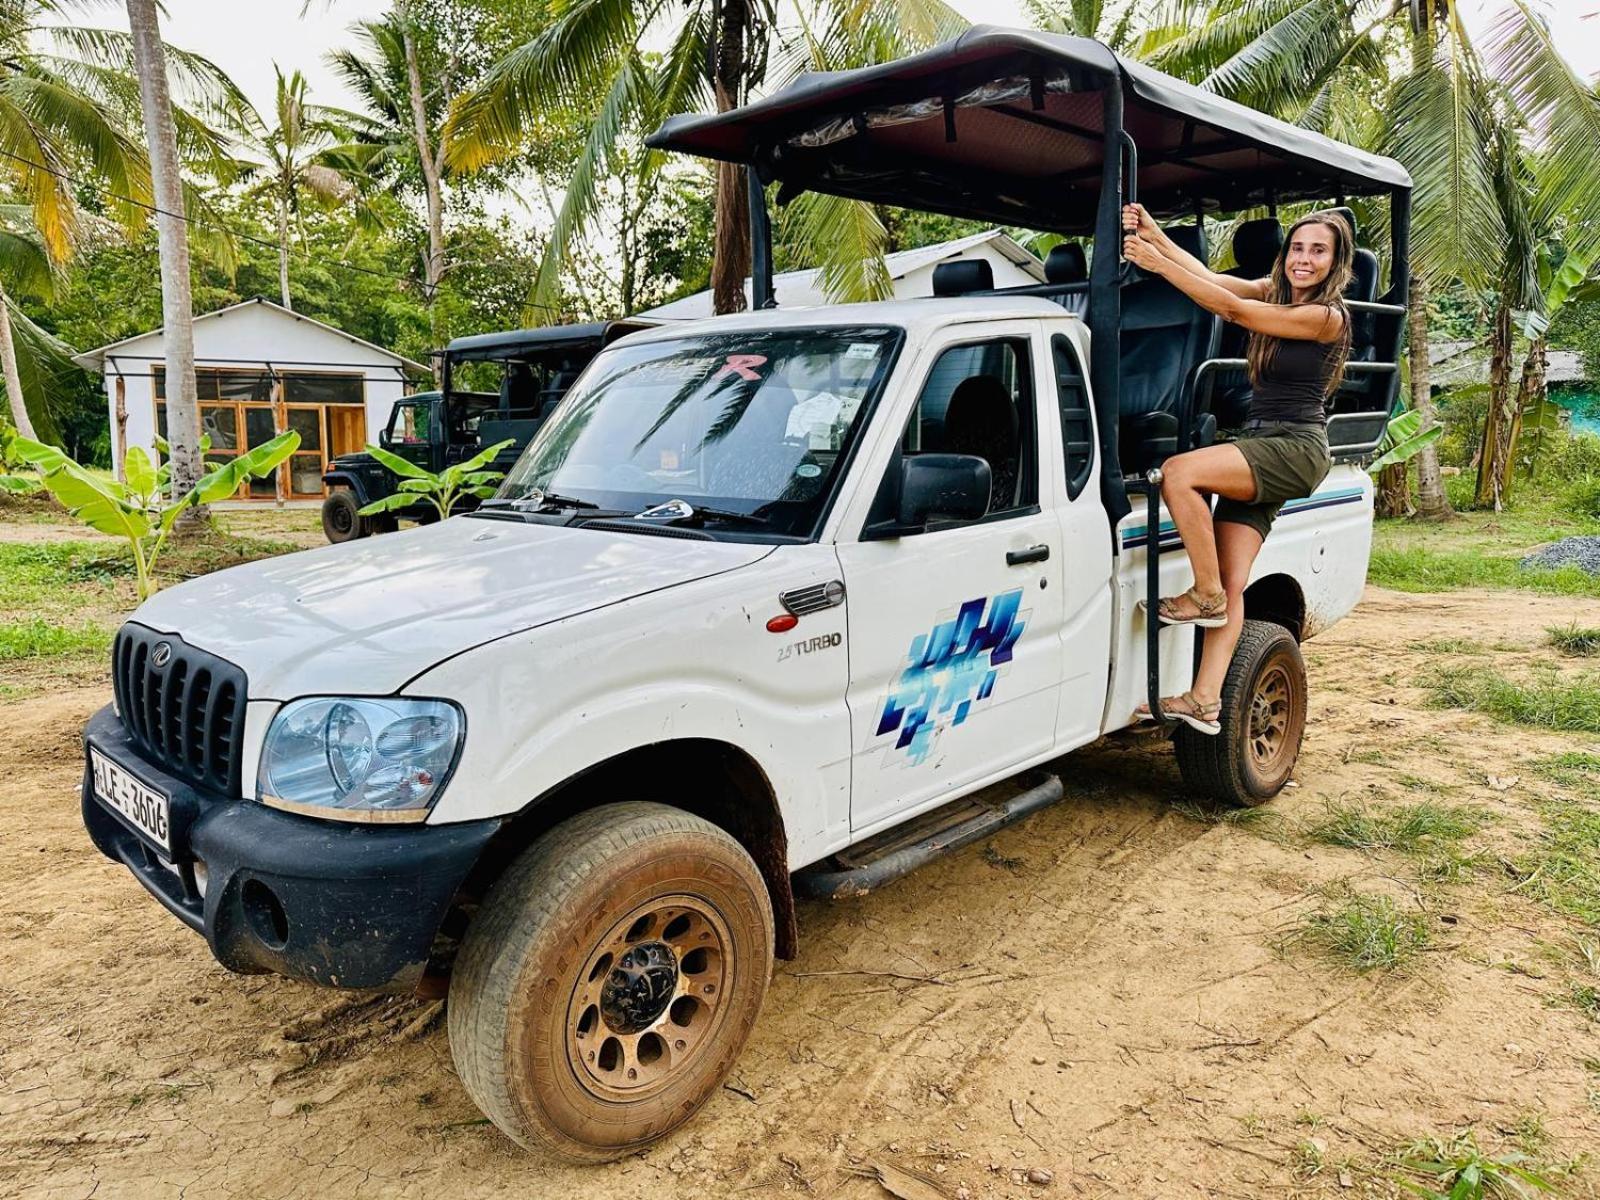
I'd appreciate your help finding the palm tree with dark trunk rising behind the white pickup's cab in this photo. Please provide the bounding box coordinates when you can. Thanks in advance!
[445,0,966,312]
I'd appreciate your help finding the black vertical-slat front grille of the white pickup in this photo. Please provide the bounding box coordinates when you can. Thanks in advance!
[110,621,245,795]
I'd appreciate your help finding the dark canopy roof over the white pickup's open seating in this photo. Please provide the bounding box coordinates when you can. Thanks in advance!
[648,26,1411,232]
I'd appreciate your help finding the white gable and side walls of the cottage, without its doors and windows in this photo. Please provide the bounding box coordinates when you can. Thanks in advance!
[104,304,405,451]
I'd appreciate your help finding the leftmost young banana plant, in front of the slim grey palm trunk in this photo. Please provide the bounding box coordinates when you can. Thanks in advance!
[11,430,299,602]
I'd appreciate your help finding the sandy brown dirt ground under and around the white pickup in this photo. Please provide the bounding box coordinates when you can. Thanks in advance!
[0,589,1600,1200]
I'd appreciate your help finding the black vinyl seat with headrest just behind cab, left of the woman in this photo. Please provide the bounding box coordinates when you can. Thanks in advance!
[1118,226,1219,474]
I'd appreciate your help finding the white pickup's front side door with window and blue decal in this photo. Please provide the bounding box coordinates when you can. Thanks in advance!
[838,322,1062,837]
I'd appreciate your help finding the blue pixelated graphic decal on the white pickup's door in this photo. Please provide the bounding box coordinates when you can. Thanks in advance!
[878,587,1026,765]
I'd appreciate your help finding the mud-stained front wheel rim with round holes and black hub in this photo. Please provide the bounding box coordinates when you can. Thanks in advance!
[566,896,733,1101]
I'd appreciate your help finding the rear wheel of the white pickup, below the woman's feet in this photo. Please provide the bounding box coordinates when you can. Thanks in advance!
[1173,621,1307,806]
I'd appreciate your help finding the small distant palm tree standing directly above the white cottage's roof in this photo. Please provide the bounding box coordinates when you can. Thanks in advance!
[224,64,381,309]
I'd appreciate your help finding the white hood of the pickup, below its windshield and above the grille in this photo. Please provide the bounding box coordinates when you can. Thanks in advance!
[131,517,773,699]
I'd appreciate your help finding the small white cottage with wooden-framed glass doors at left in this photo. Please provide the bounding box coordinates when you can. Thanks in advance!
[74,299,429,501]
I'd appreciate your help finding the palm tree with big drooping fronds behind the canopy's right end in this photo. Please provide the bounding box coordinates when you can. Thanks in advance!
[1149,0,1600,515]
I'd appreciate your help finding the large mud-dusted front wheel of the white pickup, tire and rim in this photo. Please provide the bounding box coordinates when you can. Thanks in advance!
[448,803,773,1162]
